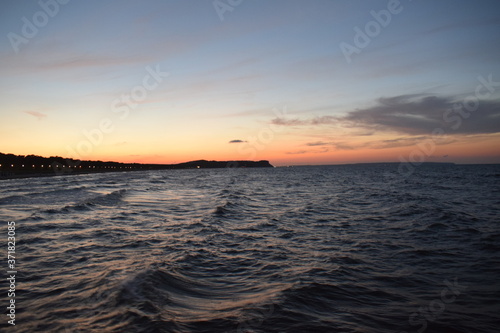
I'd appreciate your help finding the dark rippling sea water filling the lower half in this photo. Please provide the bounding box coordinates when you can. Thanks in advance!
[0,164,500,333]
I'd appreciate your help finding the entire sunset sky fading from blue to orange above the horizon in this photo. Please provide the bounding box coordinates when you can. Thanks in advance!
[0,0,500,166]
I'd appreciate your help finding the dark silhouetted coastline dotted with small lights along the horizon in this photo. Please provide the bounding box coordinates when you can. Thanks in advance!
[0,153,273,179]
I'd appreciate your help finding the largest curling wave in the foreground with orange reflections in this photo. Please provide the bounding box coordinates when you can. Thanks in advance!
[97,264,292,333]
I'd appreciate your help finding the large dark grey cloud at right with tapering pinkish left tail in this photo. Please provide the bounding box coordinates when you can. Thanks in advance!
[271,94,500,135]
